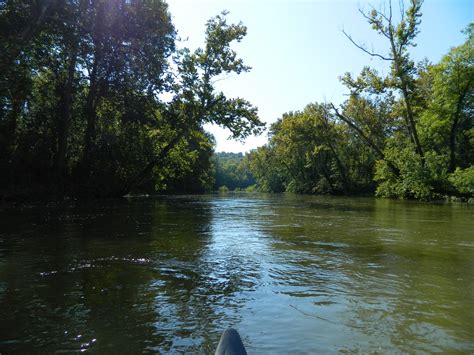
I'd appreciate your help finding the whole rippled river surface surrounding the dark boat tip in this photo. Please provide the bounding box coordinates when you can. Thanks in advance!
[0,195,474,354]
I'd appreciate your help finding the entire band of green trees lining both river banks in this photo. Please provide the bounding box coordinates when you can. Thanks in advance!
[0,0,474,200]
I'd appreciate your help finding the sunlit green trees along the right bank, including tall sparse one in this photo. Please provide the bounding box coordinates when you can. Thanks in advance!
[250,0,474,199]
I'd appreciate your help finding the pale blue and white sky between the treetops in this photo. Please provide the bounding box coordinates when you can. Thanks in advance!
[167,0,474,152]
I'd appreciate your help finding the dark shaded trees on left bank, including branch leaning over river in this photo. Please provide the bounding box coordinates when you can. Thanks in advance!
[0,0,263,197]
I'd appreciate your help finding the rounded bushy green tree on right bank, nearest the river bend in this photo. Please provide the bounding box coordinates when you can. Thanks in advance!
[250,103,374,194]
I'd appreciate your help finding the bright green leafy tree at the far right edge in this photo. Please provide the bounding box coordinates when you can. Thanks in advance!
[421,24,474,173]
